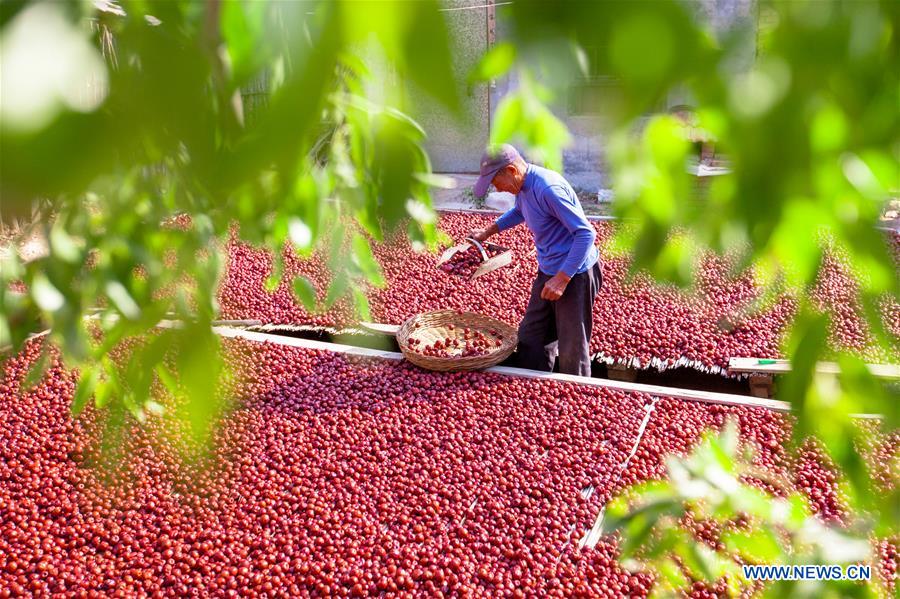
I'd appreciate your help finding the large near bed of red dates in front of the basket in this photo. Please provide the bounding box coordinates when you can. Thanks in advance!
[0,340,900,597]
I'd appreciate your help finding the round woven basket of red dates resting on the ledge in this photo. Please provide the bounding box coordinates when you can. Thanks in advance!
[397,310,518,371]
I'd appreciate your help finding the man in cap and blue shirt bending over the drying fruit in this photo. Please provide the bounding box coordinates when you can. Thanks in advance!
[471,144,602,376]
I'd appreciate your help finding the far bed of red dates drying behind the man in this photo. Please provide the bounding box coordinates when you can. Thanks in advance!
[220,213,900,373]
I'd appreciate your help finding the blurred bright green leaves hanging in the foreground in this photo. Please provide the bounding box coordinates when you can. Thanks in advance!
[0,0,900,593]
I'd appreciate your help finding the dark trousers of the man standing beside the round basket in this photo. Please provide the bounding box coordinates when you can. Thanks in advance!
[516,260,603,376]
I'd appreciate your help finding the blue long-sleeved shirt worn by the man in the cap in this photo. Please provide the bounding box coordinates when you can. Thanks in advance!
[497,164,599,277]
